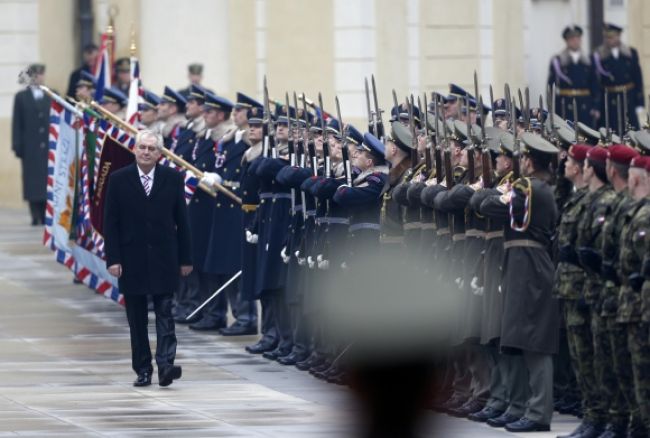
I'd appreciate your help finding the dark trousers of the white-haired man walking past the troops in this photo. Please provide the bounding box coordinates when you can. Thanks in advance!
[124,295,176,374]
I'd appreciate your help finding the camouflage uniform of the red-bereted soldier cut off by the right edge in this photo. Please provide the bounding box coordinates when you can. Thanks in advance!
[617,199,650,430]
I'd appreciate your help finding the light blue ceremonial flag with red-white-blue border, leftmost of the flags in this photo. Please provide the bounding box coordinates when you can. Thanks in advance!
[43,101,123,302]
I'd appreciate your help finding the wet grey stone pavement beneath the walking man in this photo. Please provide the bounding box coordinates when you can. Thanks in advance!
[0,210,577,438]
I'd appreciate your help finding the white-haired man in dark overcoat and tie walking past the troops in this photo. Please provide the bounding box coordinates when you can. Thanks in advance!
[104,130,192,386]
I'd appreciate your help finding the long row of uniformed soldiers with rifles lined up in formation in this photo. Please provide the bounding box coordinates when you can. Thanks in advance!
[69,48,650,437]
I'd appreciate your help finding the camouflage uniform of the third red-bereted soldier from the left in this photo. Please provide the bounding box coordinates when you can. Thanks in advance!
[601,189,641,428]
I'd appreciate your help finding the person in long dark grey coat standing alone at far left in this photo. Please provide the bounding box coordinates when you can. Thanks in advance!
[11,64,51,225]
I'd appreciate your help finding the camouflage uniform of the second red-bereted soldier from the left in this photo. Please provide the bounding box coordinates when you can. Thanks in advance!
[577,185,629,427]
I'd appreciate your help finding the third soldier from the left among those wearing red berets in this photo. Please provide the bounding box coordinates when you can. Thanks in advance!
[601,145,646,437]
